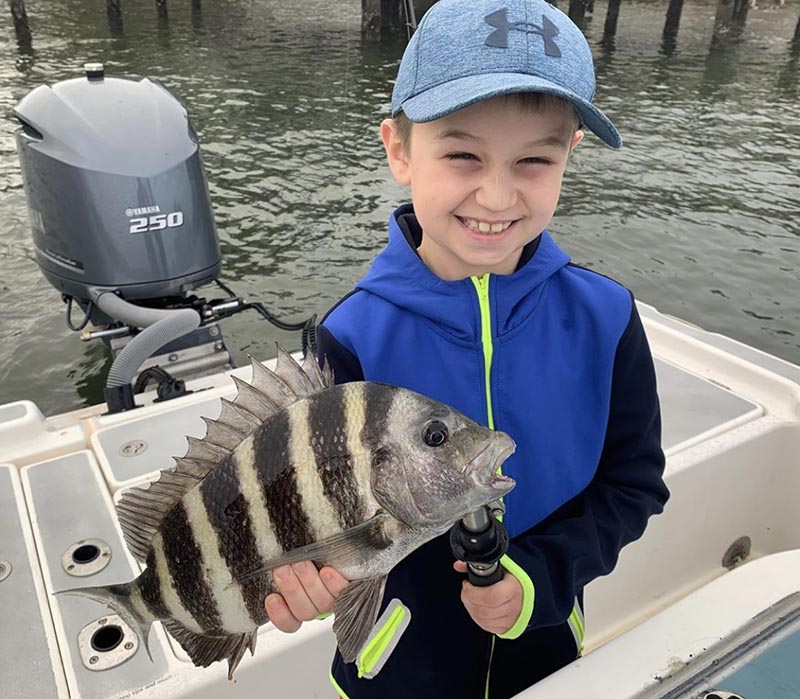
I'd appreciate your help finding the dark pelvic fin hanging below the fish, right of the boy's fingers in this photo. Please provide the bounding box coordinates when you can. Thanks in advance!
[333,575,386,663]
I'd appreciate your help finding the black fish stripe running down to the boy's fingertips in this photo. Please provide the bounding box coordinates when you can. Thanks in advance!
[200,454,271,626]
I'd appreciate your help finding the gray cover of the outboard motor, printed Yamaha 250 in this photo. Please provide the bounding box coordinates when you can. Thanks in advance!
[14,74,220,301]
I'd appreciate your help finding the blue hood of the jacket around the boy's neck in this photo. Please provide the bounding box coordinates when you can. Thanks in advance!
[356,204,570,342]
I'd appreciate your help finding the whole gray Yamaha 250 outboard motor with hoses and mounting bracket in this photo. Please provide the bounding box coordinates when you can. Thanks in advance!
[14,63,314,412]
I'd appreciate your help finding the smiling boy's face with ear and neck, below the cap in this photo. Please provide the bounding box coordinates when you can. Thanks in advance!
[381,98,583,280]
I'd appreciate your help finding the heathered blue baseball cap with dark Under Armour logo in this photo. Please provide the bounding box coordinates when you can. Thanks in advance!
[392,0,622,148]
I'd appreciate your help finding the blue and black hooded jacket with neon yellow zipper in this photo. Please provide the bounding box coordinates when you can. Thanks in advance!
[318,205,668,699]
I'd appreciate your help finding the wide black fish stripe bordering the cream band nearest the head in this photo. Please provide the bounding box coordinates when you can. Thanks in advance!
[308,386,366,529]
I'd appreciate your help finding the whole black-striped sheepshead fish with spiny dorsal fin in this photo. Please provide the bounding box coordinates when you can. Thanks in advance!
[59,348,514,677]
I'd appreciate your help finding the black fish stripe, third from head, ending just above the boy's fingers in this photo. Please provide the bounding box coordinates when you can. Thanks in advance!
[253,410,314,551]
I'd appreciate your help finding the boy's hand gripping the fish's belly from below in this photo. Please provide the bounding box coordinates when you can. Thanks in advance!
[264,561,349,633]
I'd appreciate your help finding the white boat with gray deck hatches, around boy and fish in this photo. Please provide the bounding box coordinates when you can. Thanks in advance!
[0,305,800,699]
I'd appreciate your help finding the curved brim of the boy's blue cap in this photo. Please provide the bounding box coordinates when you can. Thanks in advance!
[392,73,622,148]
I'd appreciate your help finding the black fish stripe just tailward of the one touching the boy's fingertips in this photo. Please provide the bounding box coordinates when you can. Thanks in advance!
[161,500,223,633]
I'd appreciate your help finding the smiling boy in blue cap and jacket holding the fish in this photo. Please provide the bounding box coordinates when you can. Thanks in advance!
[266,0,668,699]
